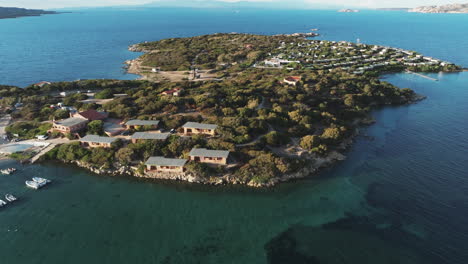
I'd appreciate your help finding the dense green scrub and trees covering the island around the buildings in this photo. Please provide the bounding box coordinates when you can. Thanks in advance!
[0,34,458,183]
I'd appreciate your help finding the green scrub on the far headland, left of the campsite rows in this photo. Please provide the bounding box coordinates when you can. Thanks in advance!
[134,34,300,71]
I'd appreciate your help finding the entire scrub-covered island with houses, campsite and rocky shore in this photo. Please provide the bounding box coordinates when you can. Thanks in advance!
[0,33,460,187]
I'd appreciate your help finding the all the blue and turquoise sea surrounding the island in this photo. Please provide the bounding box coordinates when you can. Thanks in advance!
[0,10,468,264]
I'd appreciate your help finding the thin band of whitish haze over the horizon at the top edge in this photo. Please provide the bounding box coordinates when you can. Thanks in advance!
[0,0,459,9]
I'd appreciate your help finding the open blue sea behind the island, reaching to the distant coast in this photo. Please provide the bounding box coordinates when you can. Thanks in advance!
[0,9,468,86]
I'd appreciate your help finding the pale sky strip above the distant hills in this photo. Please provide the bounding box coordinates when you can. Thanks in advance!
[0,0,460,9]
